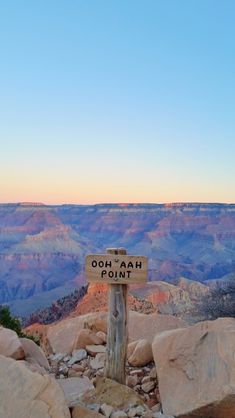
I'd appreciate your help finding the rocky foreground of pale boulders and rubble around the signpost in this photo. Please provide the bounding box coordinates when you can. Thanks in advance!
[0,312,235,418]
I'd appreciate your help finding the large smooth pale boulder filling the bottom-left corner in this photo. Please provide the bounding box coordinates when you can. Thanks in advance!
[0,356,70,418]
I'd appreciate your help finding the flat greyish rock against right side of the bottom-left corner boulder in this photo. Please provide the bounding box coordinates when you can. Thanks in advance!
[58,376,94,407]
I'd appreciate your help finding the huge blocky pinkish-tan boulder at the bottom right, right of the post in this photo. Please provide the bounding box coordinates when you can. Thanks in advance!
[152,318,235,418]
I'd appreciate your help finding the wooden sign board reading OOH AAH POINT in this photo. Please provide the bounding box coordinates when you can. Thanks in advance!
[85,254,148,284]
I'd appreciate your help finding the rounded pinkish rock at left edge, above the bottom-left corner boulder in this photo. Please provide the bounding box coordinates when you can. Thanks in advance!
[0,326,25,360]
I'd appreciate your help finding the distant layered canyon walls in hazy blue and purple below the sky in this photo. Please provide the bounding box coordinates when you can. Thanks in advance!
[0,203,235,313]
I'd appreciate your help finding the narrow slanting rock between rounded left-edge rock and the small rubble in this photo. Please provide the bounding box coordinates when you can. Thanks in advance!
[20,338,50,370]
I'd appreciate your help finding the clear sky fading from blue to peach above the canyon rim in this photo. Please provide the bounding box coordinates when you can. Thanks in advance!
[0,0,235,203]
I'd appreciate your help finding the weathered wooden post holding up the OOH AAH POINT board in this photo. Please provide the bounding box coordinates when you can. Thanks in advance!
[105,248,129,385]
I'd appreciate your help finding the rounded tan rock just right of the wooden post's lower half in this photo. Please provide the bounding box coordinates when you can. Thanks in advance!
[127,340,153,367]
